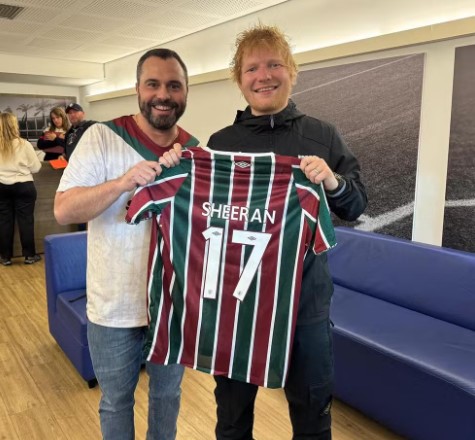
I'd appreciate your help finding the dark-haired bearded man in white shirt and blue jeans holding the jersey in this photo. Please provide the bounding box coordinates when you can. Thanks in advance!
[54,48,199,440]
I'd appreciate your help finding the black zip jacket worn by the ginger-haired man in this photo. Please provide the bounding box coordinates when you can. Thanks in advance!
[208,100,367,325]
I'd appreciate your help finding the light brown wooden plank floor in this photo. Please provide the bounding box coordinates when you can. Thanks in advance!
[0,258,400,440]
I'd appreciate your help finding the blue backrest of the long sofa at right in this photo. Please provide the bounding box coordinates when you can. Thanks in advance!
[328,227,475,330]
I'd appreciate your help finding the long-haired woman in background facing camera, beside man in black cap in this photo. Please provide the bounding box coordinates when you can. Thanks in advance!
[36,107,70,160]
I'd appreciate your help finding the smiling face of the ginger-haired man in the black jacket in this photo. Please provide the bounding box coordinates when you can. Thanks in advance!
[239,47,293,116]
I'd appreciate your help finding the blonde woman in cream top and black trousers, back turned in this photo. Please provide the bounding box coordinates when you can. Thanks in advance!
[0,113,41,266]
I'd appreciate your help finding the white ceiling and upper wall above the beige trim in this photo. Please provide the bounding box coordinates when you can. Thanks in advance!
[0,0,475,87]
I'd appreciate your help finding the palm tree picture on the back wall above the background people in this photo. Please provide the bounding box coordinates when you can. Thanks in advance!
[0,93,77,142]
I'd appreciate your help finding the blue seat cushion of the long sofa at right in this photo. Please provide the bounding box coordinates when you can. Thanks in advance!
[331,286,475,397]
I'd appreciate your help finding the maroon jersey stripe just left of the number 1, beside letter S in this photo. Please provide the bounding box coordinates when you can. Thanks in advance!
[180,158,212,368]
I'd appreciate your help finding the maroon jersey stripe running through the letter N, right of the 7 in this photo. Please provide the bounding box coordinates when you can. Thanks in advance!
[250,166,292,384]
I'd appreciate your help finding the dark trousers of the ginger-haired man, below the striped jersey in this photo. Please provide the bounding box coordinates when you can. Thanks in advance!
[215,319,333,440]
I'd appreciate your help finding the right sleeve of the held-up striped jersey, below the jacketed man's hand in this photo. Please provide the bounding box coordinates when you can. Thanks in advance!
[293,167,336,254]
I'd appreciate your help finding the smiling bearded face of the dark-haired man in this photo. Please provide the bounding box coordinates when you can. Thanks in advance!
[136,56,188,131]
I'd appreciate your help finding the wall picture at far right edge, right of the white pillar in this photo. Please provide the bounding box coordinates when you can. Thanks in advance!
[442,45,475,252]
